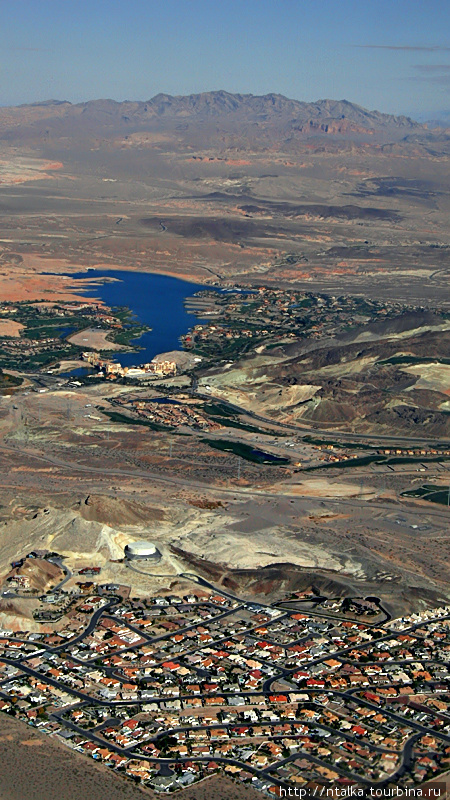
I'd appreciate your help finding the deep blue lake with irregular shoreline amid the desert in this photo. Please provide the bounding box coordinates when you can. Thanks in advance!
[69,270,213,367]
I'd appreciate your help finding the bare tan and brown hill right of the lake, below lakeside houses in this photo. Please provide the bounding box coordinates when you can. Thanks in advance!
[200,312,450,437]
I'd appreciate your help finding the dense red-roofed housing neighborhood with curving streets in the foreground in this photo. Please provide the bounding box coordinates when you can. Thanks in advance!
[0,554,450,796]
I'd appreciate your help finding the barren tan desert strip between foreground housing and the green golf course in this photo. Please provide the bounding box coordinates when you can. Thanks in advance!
[0,378,449,626]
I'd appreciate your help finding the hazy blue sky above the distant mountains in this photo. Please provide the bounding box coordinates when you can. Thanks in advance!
[0,0,450,113]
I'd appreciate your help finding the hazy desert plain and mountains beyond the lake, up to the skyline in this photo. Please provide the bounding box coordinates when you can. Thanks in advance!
[0,92,449,303]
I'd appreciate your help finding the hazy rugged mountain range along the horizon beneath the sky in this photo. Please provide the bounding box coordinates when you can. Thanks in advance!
[0,91,440,152]
